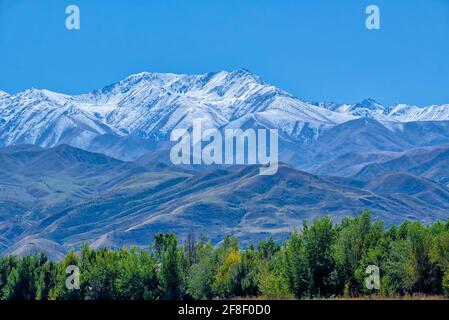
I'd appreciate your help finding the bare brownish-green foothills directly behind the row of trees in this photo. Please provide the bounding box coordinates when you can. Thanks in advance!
[0,145,449,257]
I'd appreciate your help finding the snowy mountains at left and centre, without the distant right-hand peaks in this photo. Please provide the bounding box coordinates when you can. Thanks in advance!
[0,69,354,156]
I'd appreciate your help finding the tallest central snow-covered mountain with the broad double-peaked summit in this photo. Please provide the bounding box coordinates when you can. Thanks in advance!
[75,70,349,139]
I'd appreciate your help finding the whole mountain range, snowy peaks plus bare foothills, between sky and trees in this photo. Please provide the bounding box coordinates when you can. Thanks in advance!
[0,69,449,258]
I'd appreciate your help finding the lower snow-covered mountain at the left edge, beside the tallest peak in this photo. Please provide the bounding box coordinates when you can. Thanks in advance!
[0,89,121,147]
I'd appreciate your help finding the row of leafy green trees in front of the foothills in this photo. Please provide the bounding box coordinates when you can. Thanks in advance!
[0,212,449,300]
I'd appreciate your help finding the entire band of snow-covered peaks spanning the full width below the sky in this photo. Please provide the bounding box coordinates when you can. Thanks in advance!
[0,69,449,161]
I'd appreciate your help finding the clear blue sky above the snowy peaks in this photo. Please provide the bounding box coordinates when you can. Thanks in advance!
[0,0,449,105]
